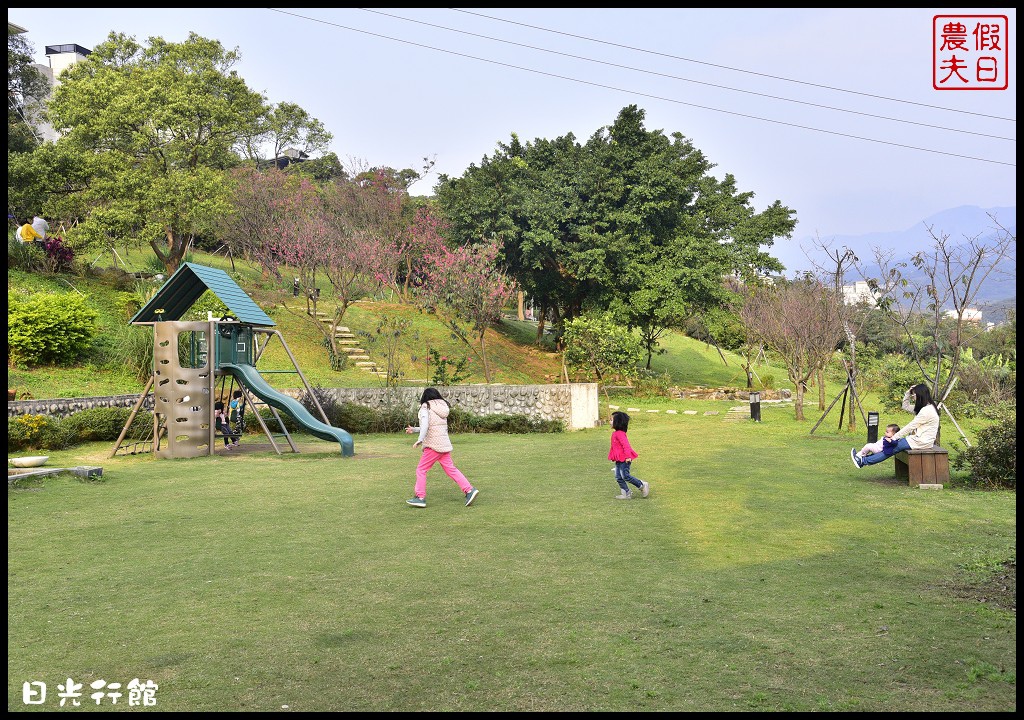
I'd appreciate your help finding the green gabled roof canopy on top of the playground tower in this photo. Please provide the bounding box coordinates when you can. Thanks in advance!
[129,262,276,327]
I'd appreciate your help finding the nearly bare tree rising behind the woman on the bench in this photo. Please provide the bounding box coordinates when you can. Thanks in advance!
[860,215,1017,441]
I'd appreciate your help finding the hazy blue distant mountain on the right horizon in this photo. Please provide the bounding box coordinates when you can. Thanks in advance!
[768,205,1017,323]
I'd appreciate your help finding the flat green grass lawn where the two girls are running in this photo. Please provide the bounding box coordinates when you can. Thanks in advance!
[7,403,1017,712]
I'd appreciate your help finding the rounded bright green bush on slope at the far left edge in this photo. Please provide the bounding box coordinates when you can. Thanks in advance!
[7,292,99,366]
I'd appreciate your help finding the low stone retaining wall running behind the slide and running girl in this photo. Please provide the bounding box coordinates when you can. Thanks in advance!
[7,383,599,430]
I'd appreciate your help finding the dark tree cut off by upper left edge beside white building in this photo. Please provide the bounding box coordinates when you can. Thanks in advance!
[7,31,50,153]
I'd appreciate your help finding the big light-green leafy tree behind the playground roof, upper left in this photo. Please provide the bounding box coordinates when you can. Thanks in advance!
[20,33,323,272]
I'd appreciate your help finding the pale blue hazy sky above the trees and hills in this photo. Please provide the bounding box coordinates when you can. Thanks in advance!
[7,7,1018,272]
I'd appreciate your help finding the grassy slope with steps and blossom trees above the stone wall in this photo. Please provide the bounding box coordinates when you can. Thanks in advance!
[7,251,782,398]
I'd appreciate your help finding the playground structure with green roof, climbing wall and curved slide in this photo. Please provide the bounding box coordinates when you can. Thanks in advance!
[110,262,354,458]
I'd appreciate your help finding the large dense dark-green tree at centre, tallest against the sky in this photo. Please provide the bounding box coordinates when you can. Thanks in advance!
[436,105,796,363]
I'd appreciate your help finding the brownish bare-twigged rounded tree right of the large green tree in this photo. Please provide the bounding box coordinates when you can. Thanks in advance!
[740,276,843,420]
